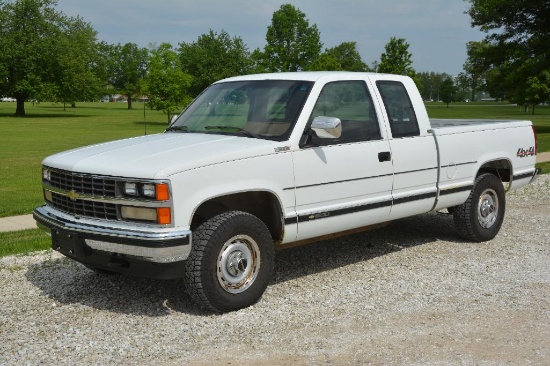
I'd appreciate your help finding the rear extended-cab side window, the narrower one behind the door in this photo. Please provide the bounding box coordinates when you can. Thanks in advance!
[376,81,420,137]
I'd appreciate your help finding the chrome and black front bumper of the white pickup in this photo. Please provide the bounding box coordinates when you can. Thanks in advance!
[33,205,191,278]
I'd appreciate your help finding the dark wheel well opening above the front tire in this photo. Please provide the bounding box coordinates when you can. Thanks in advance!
[191,191,284,242]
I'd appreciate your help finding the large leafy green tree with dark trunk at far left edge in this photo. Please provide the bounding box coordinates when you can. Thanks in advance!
[0,0,95,116]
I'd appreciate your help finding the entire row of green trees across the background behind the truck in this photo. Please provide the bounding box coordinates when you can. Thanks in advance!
[0,0,550,118]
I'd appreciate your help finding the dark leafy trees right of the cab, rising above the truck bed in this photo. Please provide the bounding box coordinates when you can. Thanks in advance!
[424,0,550,114]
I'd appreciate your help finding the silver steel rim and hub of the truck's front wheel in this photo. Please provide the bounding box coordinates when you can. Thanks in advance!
[217,235,260,294]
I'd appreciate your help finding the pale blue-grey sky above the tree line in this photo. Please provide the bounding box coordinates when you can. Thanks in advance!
[57,0,485,75]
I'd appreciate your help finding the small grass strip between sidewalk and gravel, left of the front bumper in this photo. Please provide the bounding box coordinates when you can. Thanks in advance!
[0,229,52,257]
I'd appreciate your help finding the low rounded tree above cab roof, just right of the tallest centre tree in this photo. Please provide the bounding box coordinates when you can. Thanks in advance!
[307,42,369,71]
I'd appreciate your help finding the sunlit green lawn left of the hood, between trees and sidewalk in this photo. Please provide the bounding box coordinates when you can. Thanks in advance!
[0,103,167,217]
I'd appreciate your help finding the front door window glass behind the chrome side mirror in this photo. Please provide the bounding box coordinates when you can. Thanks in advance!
[309,80,381,146]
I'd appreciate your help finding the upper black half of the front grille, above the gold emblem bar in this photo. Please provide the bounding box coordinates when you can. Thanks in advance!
[49,170,116,197]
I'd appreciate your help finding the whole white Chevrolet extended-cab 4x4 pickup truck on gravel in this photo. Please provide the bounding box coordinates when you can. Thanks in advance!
[34,72,539,312]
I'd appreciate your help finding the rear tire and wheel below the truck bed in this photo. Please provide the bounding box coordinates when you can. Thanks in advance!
[453,173,506,242]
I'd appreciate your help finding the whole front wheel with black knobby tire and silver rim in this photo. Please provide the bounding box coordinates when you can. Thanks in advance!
[184,211,274,313]
